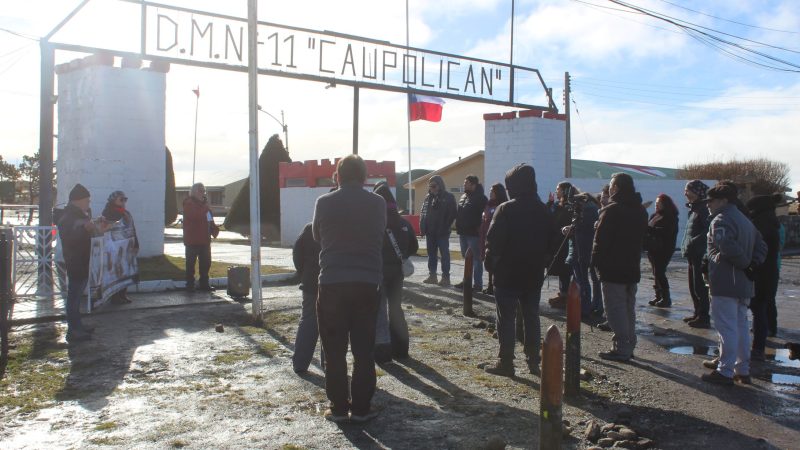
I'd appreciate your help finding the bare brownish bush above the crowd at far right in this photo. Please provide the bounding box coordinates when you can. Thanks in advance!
[677,158,789,194]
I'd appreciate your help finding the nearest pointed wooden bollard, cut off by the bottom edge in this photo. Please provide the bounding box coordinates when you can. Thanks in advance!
[539,325,564,450]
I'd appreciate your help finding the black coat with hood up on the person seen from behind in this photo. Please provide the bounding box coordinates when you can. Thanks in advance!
[484,167,560,291]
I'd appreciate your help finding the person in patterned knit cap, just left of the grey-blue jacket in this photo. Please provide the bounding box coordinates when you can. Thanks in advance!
[681,180,711,328]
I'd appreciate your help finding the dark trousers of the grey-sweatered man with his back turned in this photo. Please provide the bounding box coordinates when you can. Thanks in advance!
[317,283,380,415]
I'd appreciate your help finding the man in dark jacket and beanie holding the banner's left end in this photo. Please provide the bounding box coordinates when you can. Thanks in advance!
[58,183,109,343]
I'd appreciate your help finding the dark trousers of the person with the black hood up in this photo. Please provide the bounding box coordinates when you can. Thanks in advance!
[494,282,542,365]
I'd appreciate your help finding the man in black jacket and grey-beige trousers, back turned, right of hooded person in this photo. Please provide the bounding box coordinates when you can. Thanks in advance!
[591,173,647,361]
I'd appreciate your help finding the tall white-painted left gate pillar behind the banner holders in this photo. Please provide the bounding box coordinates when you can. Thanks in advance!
[56,66,166,257]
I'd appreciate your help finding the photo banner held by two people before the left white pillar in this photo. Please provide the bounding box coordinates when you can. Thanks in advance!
[89,221,139,308]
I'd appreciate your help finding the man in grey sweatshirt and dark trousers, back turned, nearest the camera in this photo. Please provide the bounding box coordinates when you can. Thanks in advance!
[311,155,386,422]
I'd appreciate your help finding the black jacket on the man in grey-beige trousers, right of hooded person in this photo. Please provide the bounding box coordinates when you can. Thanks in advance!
[591,192,647,284]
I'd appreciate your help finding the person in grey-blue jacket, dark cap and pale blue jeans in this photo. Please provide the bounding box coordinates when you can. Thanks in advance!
[701,184,767,385]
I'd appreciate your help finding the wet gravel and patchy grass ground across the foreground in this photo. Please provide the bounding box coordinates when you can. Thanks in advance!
[0,258,800,449]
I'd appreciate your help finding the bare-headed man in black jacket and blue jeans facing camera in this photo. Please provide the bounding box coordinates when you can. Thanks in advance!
[455,175,488,291]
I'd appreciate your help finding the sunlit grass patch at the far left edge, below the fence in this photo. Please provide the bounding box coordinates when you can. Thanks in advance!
[0,329,70,413]
